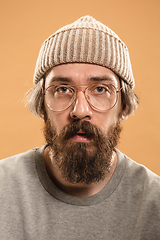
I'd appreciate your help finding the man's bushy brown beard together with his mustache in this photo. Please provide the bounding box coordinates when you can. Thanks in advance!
[44,117,122,184]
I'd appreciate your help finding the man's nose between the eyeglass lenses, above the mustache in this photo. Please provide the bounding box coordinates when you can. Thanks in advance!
[70,91,92,120]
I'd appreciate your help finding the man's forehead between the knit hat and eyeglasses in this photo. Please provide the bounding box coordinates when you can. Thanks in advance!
[45,63,120,87]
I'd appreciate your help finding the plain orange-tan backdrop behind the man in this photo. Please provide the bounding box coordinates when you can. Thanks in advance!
[0,0,160,175]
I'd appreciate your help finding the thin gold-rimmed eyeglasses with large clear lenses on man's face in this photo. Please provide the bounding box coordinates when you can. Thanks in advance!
[43,83,122,112]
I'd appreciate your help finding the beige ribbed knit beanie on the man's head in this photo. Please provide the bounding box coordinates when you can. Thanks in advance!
[34,16,135,88]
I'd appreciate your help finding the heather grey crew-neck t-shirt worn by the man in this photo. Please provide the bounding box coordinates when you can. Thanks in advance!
[0,146,160,240]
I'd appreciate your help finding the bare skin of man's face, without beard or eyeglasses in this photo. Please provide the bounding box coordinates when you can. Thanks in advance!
[45,63,121,135]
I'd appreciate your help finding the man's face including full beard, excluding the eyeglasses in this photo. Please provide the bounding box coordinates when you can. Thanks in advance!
[44,63,121,184]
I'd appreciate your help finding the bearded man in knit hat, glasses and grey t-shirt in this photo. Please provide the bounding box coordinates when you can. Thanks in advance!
[0,16,160,240]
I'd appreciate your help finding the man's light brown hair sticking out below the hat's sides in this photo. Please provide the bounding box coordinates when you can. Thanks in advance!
[25,77,139,117]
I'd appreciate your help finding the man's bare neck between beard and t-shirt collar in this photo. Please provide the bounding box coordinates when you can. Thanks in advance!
[44,147,117,197]
